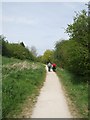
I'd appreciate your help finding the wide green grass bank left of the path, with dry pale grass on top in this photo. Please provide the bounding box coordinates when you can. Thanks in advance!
[2,58,46,118]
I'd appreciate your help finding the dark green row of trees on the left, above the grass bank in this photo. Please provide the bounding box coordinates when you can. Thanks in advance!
[0,35,35,60]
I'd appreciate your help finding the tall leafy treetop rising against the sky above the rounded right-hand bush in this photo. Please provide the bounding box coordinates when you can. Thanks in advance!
[66,10,88,47]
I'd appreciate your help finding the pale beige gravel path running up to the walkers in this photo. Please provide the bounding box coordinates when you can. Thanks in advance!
[31,68,72,118]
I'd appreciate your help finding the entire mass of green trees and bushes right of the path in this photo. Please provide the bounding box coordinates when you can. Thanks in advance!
[54,10,90,81]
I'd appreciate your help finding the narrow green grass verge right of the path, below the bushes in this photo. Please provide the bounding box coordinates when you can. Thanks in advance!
[57,68,88,118]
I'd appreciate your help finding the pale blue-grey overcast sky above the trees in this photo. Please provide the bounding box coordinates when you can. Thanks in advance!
[2,2,87,55]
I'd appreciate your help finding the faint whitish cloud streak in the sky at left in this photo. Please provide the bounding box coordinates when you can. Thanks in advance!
[3,16,37,25]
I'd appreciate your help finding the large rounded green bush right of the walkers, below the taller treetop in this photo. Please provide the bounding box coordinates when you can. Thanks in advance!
[55,40,89,75]
